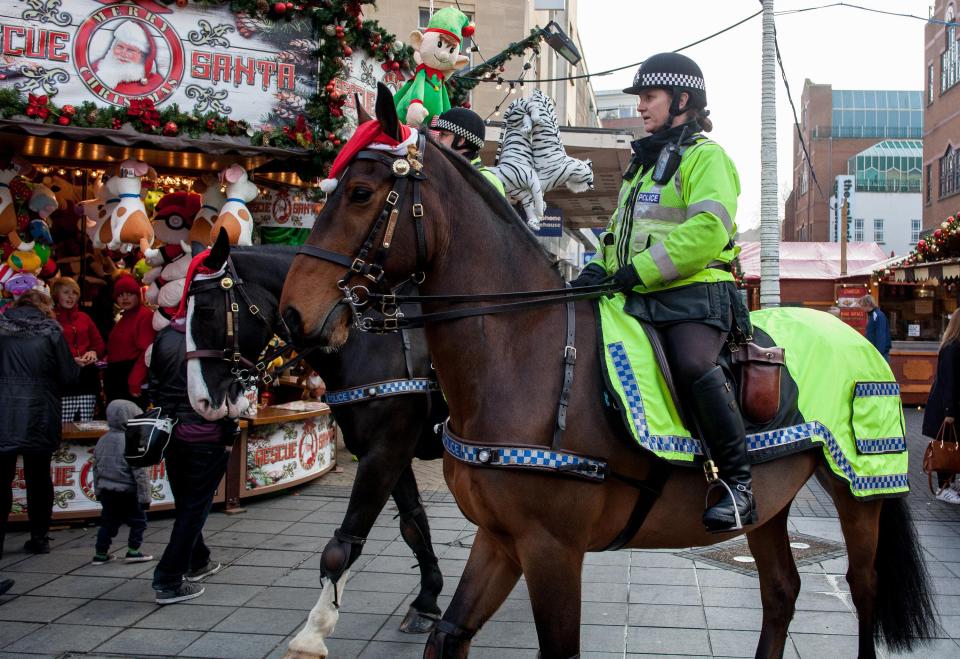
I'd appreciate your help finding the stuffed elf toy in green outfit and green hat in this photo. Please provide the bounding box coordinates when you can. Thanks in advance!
[393,7,473,127]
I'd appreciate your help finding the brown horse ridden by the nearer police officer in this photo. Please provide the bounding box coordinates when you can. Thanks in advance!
[281,88,936,659]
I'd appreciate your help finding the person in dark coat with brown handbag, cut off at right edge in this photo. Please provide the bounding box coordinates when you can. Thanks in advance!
[921,312,960,504]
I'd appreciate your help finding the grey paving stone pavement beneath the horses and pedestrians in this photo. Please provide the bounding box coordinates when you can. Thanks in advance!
[0,410,960,659]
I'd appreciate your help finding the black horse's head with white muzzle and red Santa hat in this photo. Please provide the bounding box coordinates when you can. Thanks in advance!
[184,232,277,421]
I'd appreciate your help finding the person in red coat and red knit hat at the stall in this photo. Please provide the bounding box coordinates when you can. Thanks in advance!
[103,273,156,407]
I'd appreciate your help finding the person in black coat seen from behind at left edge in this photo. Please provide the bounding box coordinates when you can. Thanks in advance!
[0,291,80,555]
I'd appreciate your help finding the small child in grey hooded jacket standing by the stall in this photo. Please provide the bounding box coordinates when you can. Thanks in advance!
[93,400,153,565]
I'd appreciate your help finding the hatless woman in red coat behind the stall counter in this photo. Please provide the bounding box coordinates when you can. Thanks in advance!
[51,277,106,422]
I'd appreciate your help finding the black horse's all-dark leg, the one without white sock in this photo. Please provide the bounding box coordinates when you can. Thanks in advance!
[393,465,443,634]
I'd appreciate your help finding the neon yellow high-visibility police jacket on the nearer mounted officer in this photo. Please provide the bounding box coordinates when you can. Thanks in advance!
[594,135,740,292]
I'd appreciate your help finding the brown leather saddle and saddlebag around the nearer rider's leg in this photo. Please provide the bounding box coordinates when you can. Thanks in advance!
[640,321,785,427]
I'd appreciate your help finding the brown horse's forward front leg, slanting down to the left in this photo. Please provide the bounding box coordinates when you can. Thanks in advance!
[423,528,520,659]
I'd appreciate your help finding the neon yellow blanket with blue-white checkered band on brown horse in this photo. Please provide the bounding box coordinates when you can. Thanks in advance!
[598,294,909,498]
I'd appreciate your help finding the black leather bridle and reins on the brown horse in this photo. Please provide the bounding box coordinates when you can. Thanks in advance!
[297,133,618,333]
